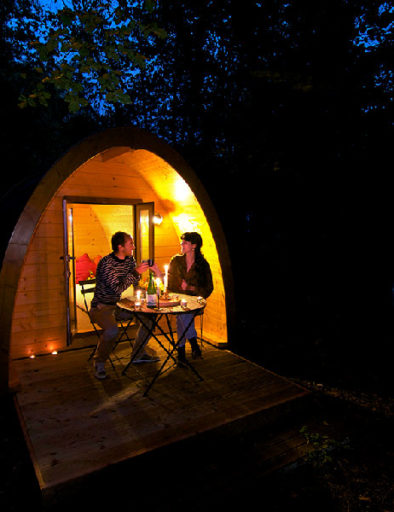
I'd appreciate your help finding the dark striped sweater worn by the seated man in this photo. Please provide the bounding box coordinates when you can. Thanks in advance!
[92,252,141,307]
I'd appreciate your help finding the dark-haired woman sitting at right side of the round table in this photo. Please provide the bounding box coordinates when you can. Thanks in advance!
[168,231,213,365]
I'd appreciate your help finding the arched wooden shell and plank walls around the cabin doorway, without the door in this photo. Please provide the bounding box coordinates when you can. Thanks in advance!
[0,127,234,390]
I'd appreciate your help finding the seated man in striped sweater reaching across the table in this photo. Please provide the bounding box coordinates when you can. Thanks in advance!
[90,231,161,380]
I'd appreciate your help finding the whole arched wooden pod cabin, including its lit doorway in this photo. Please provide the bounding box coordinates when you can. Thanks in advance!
[0,127,234,389]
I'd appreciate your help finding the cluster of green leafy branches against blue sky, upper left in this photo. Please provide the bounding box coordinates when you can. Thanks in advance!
[14,0,167,112]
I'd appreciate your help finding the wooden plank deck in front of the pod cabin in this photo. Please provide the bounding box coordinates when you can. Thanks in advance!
[13,342,308,506]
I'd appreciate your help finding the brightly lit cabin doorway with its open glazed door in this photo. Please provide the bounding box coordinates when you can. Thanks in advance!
[63,197,154,345]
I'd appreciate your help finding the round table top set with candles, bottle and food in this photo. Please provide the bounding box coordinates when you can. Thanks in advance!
[117,293,207,315]
